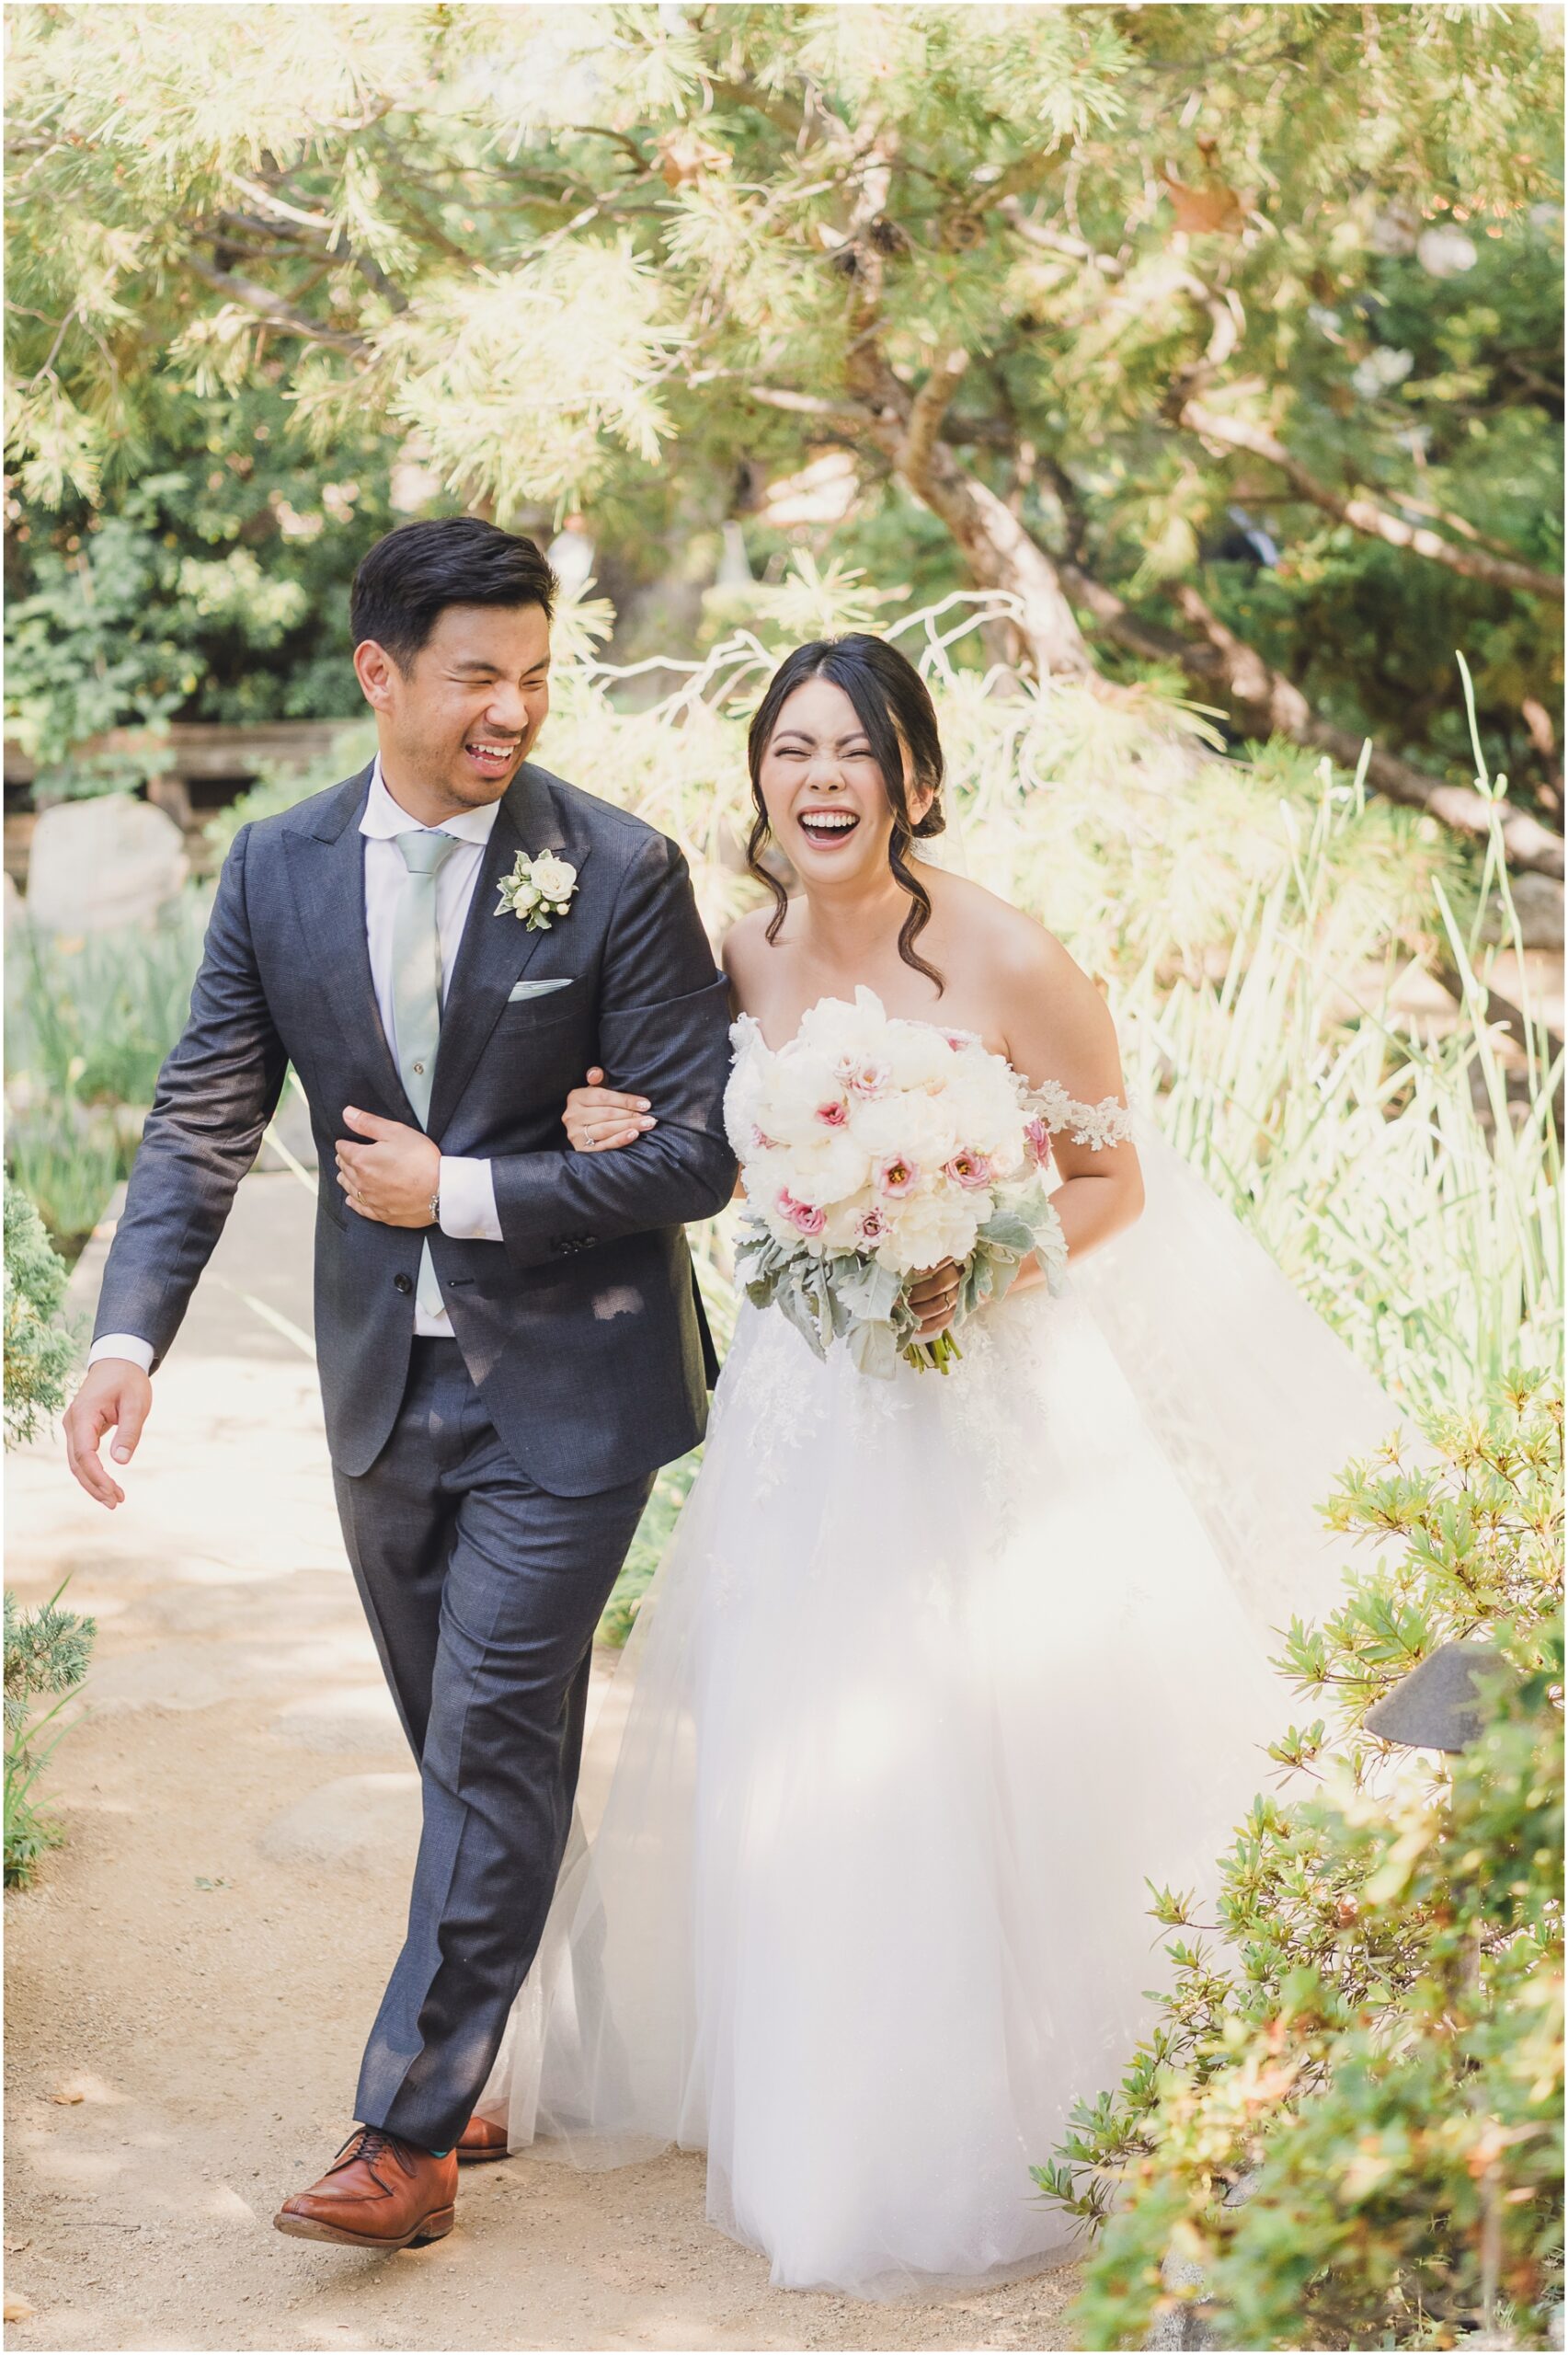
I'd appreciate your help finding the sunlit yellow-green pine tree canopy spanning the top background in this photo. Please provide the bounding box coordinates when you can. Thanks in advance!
[9,0,1561,789]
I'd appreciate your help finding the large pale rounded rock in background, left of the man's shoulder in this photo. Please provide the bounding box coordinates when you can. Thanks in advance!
[26,794,190,933]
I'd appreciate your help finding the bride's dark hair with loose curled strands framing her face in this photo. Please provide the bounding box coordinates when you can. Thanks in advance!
[747,631,946,989]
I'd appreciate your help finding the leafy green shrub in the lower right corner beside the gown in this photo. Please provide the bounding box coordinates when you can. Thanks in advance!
[1036,1375,1563,2348]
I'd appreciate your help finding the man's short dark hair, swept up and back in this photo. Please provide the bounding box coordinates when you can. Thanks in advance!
[349,516,560,672]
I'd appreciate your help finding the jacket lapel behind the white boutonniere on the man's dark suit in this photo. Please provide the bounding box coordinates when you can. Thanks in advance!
[429,763,589,1137]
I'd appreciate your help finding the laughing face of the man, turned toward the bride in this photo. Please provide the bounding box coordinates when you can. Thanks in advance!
[356,605,551,810]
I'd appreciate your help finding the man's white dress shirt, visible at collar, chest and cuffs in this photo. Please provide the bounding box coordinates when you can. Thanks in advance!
[87,753,501,1373]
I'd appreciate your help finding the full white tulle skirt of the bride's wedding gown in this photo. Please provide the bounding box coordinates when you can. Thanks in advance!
[480,1022,1396,2299]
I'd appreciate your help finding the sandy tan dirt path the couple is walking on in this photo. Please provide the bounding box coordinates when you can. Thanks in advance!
[5,1175,1071,2350]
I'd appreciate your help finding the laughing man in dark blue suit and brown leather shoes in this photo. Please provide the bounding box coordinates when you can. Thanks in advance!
[66,516,735,2249]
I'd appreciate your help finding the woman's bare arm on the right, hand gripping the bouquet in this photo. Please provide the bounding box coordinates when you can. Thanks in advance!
[1008,924,1144,1291]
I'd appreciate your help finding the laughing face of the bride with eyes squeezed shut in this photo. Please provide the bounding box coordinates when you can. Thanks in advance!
[758,678,930,888]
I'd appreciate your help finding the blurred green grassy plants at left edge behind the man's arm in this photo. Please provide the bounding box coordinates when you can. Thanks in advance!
[5,890,207,1258]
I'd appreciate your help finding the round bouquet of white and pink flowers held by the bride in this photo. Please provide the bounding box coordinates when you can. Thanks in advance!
[727,989,1067,1378]
